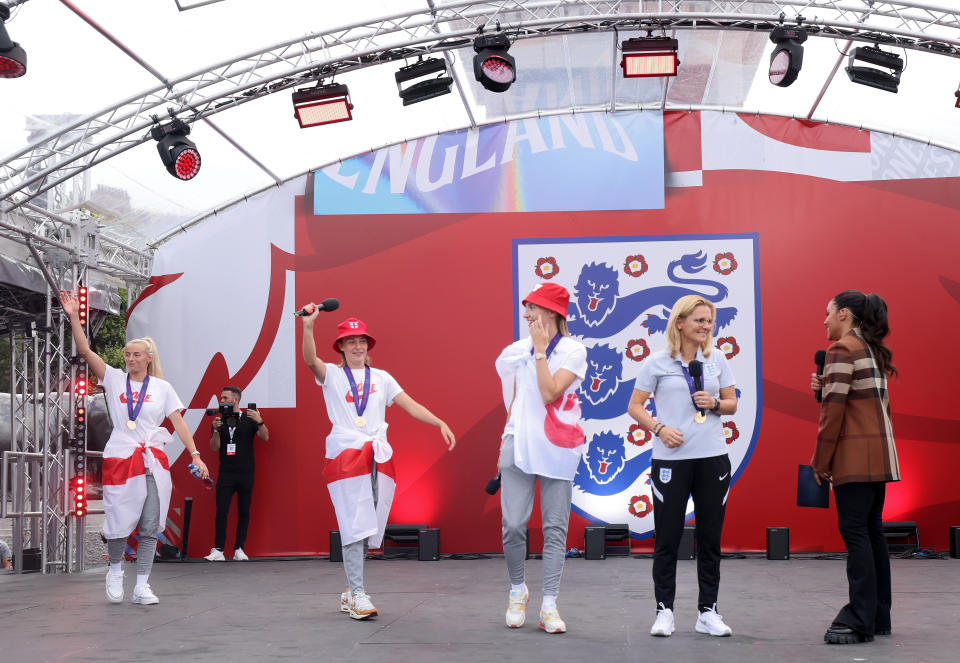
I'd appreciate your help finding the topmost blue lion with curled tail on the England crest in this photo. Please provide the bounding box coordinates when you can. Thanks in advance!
[567,251,737,338]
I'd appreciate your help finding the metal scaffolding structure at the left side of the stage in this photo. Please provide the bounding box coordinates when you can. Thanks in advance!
[0,195,152,574]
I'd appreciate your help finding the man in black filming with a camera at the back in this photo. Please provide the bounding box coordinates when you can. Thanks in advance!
[204,387,270,562]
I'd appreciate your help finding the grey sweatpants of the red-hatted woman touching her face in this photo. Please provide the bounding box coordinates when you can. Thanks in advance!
[499,435,573,596]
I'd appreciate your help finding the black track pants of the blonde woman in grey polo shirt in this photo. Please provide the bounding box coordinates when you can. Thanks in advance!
[650,454,730,612]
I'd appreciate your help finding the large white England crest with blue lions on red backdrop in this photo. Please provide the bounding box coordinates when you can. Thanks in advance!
[513,233,761,539]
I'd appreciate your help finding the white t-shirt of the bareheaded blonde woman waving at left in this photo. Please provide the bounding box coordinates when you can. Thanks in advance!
[100,366,184,452]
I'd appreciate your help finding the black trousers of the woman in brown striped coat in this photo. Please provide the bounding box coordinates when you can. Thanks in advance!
[833,482,891,635]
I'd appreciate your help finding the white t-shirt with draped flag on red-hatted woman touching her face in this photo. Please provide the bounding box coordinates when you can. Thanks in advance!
[496,336,587,481]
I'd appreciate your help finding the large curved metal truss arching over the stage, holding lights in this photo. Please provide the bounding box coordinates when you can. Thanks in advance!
[0,0,960,213]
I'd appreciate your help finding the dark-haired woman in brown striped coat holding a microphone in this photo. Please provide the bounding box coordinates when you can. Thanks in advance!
[810,290,900,644]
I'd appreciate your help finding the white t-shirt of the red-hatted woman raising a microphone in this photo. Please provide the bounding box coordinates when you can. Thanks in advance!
[317,364,403,432]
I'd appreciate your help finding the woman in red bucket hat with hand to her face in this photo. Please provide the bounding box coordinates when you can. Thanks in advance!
[496,283,587,633]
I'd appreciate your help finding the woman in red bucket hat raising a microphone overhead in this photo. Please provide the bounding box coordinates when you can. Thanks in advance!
[301,310,457,619]
